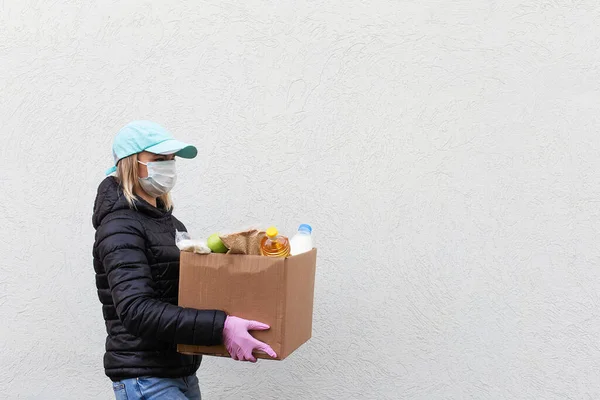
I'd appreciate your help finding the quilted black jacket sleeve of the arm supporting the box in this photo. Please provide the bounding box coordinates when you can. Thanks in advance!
[96,217,226,346]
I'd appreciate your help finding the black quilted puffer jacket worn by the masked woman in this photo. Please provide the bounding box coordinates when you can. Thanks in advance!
[93,177,225,381]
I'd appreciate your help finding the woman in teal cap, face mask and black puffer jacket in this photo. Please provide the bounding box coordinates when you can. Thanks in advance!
[93,121,276,400]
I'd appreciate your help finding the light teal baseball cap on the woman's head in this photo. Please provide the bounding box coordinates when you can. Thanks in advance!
[106,121,198,175]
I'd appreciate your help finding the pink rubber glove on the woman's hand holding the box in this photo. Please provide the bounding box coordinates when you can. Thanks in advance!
[223,316,277,362]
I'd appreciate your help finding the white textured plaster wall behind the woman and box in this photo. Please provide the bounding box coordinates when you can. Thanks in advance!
[0,0,600,400]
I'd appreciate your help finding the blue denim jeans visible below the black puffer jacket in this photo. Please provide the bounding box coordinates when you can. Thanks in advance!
[113,375,201,400]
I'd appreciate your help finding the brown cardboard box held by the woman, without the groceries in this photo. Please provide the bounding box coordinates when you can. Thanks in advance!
[177,249,317,360]
